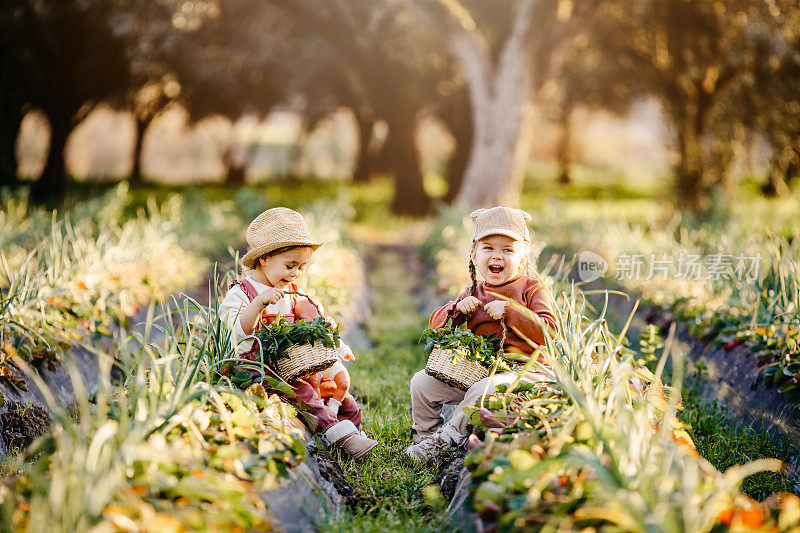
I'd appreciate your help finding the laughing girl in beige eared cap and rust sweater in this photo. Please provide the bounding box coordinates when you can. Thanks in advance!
[405,206,557,461]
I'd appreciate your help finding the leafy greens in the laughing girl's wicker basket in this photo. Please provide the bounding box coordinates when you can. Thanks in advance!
[420,326,511,372]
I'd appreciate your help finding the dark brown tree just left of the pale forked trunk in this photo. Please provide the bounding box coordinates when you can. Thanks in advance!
[276,0,454,215]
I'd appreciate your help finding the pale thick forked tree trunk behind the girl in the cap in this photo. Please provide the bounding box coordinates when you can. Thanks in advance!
[415,0,594,207]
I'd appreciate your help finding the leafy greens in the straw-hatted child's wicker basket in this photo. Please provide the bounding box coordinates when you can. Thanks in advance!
[255,316,339,367]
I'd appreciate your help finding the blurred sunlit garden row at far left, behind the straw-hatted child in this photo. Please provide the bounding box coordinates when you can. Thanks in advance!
[0,185,247,396]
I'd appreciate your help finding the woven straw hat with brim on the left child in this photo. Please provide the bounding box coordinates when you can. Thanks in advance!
[242,207,322,268]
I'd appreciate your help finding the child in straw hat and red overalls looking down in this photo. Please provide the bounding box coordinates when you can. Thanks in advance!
[219,207,377,457]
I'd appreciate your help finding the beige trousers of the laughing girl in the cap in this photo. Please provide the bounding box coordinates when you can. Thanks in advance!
[411,370,527,445]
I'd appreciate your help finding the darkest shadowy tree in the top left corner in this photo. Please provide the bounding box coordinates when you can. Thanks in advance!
[0,0,130,200]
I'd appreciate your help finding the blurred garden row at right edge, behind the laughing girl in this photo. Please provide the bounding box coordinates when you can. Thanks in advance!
[535,200,800,405]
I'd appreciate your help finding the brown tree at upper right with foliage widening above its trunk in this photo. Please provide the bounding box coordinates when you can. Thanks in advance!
[595,0,773,211]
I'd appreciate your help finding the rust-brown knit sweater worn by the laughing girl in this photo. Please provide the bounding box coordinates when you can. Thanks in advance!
[430,276,558,354]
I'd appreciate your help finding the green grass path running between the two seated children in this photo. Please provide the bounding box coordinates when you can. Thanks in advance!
[328,248,447,532]
